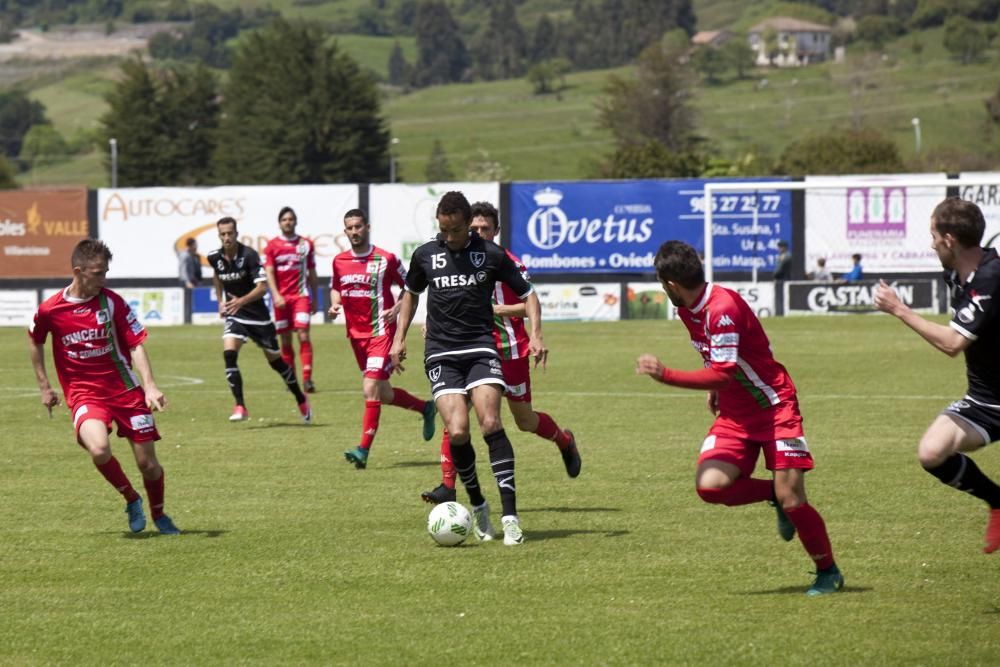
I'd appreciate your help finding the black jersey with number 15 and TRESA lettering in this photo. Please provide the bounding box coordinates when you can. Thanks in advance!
[406,232,532,356]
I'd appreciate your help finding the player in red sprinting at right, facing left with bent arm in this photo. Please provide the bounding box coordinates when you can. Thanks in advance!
[636,241,844,596]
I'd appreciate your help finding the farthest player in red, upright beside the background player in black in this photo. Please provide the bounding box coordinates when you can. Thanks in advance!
[264,206,319,394]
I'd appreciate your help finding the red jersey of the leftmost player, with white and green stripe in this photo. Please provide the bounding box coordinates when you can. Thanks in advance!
[28,288,146,406]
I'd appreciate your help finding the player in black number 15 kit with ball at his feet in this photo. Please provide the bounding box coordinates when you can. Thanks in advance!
[389,192,548,546]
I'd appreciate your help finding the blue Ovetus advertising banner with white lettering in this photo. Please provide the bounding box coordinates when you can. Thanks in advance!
[510,179,792,274]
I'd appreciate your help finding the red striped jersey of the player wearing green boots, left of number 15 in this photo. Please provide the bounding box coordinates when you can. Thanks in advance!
[330,246,406,338]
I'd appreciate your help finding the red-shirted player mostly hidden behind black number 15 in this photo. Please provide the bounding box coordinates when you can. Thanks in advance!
[420,202,581,503]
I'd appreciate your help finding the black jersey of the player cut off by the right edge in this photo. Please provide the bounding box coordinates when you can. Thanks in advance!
[944,248,1000,409]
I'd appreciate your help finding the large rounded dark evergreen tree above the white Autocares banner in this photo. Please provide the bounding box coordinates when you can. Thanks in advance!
[215,18,389,183]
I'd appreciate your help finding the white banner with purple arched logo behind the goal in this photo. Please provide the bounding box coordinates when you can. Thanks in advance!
[793,174,947,277]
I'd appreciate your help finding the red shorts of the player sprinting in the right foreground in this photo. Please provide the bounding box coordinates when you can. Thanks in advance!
[698,401,814,477]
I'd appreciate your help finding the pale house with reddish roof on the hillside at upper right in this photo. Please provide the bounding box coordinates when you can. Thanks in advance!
[747,16,832,67]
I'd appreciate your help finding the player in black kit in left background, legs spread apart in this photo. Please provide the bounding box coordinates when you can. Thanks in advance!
[208,217,312,424]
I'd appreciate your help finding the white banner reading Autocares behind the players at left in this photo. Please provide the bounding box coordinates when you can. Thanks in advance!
[97,185,358,278]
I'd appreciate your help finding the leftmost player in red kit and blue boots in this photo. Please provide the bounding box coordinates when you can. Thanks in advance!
[28,239,180,535]
